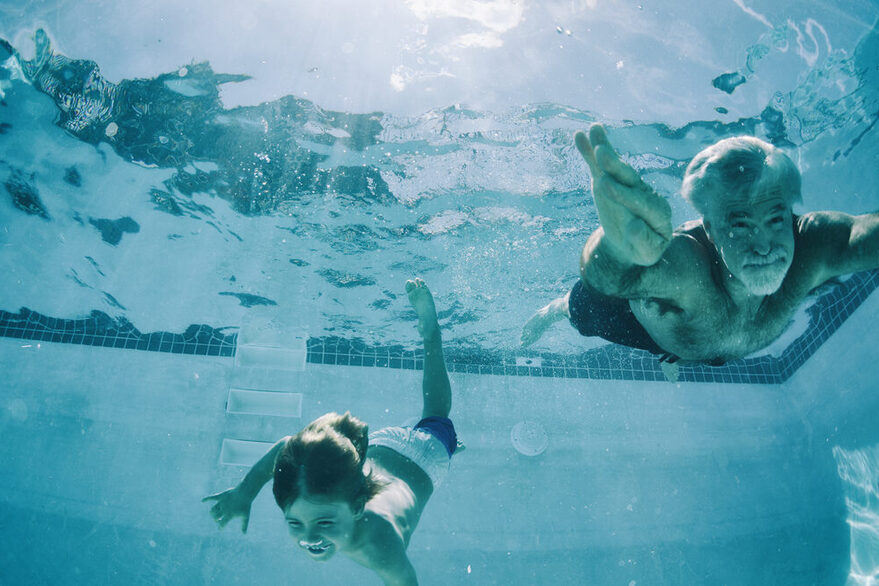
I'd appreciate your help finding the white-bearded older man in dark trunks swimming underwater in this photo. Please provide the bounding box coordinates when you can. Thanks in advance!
[521,124,879,364]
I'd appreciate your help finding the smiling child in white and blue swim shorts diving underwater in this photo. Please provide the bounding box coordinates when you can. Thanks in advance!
[203,279,457,586]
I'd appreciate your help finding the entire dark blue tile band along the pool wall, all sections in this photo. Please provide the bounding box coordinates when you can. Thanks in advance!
[0,270,879,384]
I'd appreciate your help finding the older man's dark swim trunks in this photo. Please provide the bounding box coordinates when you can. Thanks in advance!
[568,280,666,354]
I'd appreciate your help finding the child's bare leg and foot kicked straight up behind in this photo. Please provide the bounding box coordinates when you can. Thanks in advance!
[406,279,452,417]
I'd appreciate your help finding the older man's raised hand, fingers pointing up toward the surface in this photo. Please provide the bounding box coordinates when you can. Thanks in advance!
[574,124,672,266]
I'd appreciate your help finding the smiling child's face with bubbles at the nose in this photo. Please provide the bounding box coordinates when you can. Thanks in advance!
[284,495,362,562]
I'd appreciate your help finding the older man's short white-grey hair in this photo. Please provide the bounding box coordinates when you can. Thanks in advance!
[681,136,801,216]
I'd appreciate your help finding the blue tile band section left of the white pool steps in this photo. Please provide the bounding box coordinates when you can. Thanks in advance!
[0,307,238,356]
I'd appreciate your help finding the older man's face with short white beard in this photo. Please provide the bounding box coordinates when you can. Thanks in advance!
[705,191,794,295]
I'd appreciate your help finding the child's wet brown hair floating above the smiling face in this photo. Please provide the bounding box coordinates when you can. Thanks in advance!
[272,412,384,513]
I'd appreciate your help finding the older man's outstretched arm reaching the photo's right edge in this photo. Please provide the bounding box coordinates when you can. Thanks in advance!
[800,212,879,286]
